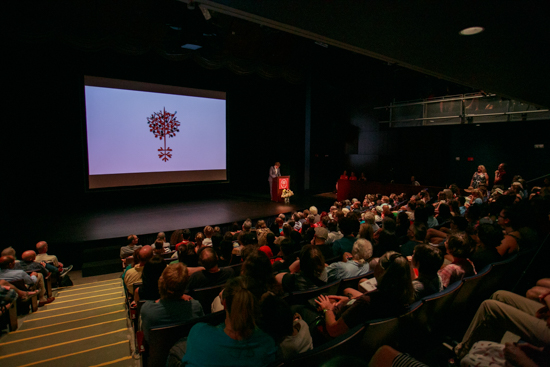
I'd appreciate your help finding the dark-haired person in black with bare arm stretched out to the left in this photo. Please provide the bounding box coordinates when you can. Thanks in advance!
[315,252,414,337]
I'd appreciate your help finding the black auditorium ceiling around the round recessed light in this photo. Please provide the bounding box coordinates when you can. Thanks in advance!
[4,0,550,108]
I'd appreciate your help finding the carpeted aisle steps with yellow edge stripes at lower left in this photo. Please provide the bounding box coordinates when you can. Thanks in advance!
[0,272,139,367]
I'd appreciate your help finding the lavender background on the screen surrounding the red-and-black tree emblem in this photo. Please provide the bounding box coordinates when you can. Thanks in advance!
[85,86,226,175]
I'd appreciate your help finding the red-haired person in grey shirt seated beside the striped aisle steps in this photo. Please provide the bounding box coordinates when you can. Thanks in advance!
[140,263,204,340]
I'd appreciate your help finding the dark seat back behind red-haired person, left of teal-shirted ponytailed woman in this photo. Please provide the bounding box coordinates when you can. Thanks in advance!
[147,311,225,367]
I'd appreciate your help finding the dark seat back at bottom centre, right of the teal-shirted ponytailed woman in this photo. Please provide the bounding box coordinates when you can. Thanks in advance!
[284,325,366,367]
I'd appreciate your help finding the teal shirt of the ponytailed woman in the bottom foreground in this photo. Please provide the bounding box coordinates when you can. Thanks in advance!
[182,322,278,367]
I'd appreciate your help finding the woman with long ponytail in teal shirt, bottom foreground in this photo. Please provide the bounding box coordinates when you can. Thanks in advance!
[182,277,278,366]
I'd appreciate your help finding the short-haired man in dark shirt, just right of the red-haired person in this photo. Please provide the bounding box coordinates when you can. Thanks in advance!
[185,247,234,293]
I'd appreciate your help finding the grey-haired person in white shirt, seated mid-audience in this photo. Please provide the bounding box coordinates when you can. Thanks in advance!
[327,239,372,282]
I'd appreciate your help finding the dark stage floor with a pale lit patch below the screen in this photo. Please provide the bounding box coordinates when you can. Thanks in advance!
[27,193,335,244]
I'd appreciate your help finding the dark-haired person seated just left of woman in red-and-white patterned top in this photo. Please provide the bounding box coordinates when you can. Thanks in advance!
[412,244,443,301]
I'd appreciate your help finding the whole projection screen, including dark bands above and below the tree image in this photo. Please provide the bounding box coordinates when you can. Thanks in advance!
[84,77,227,189]
